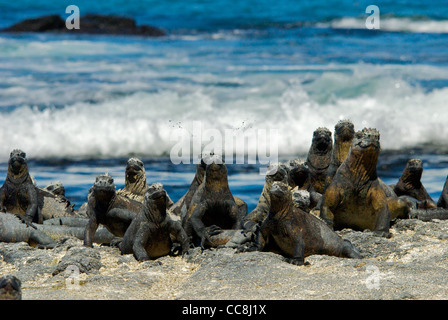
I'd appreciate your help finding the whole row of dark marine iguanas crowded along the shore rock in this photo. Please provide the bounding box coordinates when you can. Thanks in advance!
[0,120,448,298]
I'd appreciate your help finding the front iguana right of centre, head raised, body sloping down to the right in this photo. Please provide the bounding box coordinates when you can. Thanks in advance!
[239,182,362,265]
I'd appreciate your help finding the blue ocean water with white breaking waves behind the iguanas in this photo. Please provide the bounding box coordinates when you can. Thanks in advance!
[0,0,448,209]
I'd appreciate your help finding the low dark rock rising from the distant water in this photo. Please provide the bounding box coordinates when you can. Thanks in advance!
[0,14,165,37]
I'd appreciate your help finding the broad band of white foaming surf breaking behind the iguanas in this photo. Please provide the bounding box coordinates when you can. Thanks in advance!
[0,64,448,160]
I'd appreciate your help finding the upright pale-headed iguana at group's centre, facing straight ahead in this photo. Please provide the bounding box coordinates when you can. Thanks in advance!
[183,155,247,248]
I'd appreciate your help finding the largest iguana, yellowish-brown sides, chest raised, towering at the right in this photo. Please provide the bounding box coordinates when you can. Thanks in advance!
[320,128,409,237]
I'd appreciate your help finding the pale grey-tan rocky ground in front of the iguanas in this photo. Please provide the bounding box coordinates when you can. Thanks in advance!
[0,219,448,300]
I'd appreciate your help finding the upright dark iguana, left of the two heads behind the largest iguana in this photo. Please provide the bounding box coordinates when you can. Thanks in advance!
[306,128,333,194]
